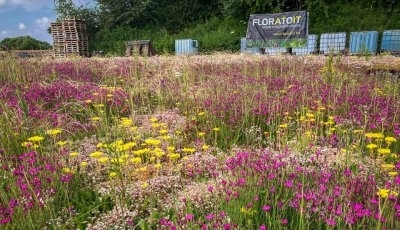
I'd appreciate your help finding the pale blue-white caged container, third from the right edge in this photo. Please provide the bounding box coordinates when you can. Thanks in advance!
[319,32,346,55]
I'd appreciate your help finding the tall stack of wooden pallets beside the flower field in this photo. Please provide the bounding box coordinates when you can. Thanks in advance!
[51,18,89,58]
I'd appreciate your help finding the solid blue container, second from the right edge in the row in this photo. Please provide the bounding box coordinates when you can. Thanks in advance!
[349,31,378,54]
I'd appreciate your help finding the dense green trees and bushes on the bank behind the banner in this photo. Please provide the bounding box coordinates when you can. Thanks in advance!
[55,0,400,55]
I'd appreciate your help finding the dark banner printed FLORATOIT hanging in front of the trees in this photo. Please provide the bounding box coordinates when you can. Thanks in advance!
[246,11,308,47]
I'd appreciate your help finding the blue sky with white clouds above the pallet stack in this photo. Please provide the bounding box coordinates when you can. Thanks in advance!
[0,0,93,44]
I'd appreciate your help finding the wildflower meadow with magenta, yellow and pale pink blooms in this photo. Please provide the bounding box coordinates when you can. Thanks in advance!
[0,54,400,230]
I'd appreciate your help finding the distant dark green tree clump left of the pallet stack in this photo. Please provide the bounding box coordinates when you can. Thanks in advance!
[0,36,52,50]
